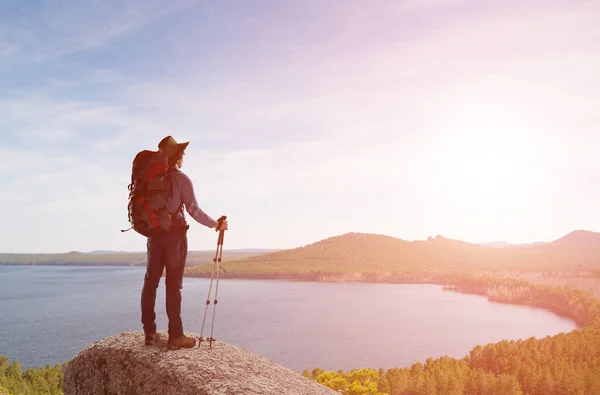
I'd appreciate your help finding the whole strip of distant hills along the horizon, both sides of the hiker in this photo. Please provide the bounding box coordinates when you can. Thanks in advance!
[8,230,600,273]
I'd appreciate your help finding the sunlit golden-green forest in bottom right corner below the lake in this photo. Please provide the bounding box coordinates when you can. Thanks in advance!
[303,321,600,395]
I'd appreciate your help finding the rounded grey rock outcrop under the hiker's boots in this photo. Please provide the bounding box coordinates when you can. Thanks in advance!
[64,331,339,395]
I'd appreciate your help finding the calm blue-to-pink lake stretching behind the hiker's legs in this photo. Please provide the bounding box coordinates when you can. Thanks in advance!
[0,266,576,372]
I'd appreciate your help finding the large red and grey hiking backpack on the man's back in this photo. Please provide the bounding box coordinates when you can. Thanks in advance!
[123,150,179,237]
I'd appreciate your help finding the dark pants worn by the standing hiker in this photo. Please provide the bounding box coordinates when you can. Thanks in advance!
[142,233,187,338]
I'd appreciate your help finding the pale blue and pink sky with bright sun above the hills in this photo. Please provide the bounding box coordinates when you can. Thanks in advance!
[0,0,600,252]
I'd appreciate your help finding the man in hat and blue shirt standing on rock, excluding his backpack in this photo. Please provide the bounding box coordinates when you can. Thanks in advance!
[141,136,228,350]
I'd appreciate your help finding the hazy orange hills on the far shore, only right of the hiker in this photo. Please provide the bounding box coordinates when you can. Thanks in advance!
[186,231,600,277]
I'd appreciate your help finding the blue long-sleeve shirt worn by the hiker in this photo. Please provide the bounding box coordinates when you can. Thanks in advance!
[167,169,217,228]
